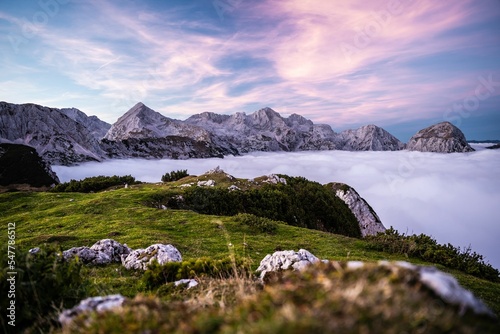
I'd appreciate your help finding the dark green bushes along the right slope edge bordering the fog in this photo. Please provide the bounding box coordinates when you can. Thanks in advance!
[366,227,500,282]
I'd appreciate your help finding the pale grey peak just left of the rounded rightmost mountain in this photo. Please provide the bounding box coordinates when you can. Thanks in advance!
[339,125,405,151]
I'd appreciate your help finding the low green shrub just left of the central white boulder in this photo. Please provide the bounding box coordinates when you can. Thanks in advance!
[141,257,250,290]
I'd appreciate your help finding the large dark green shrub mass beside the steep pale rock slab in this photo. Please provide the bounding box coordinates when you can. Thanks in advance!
[145,175,361,238]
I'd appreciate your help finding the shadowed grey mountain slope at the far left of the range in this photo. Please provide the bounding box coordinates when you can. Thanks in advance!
[0,102,103,165]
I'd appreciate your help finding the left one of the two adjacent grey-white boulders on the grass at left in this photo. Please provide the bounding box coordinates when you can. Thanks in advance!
[63,239,132,265]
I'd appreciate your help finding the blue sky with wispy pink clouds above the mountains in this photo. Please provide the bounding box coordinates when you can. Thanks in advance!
[0,0,500,141]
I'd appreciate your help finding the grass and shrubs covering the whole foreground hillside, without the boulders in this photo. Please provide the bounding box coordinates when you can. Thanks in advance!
[0,173,500,333]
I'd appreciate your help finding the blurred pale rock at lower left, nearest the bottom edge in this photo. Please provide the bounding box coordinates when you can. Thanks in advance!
[59,294,126,326]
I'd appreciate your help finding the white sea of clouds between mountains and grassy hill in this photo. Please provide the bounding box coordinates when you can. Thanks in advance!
[53,145,500,268]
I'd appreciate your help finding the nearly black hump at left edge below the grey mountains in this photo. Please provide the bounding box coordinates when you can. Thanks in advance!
[0,144,59,187]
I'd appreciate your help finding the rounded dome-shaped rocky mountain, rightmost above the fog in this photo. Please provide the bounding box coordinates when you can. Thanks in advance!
[407,122,474,153]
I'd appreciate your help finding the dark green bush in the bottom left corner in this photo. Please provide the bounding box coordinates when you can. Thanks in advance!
[0,248,88,333]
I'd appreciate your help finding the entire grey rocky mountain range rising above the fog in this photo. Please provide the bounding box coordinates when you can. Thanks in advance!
[0,102,473,165]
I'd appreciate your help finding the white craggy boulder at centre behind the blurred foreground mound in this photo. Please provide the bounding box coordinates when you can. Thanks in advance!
[257,249,319,279]
